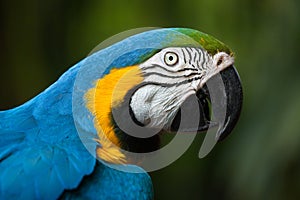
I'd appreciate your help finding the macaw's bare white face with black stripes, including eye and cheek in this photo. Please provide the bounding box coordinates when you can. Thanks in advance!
[130,47,234,128]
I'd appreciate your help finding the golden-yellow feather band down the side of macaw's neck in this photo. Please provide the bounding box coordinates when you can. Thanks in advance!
[85,66,143,164]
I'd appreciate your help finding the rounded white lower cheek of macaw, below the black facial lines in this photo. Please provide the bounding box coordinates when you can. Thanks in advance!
[130,85,195,128]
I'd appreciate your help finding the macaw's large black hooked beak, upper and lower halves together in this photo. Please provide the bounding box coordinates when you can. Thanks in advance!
[170,65,243,141]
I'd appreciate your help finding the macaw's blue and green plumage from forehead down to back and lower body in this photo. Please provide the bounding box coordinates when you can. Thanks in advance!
[0,28,229,199]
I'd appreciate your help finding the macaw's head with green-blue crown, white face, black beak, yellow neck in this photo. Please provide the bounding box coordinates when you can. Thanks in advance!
[85,28,243,166]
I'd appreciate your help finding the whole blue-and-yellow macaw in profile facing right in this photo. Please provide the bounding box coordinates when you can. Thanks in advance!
[0,28,242,199]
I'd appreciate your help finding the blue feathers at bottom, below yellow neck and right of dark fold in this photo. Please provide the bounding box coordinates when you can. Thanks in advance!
[61,162,154,200]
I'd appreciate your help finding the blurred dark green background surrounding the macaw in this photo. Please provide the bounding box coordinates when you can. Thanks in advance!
[0,0,300,199]
